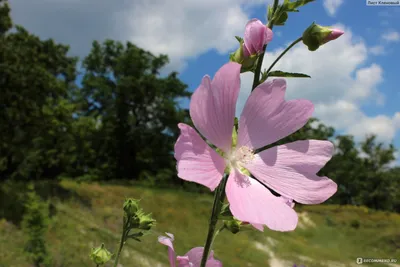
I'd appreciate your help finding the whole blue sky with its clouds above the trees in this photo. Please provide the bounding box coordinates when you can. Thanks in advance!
[10,0,400,161]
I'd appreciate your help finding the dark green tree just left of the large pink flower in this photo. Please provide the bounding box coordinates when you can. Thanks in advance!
[80,40,190,179]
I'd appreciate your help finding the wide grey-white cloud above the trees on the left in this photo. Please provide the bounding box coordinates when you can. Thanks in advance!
[7,0,265,69]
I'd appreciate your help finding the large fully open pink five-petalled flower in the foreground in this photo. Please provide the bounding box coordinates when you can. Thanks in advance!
[175,62,337,231]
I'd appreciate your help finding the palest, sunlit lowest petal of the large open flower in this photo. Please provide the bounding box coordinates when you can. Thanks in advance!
[226,170,298,232]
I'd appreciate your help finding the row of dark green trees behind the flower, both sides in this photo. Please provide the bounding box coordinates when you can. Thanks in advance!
[0,0,400,212]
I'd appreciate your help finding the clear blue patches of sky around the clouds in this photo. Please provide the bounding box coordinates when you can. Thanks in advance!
[180,1,400,151]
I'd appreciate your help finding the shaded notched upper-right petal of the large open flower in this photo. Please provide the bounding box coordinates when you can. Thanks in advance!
[238,79,314,149]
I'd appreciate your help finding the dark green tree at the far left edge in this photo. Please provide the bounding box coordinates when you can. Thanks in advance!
[0,1,77,179]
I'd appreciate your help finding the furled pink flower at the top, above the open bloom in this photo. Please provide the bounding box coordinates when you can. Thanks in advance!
[243,19,273,57]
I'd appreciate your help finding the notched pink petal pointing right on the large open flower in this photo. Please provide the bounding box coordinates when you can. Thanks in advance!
[245,140,337,204]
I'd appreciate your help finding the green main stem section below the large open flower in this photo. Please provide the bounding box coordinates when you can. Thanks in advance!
[200,174,228,267]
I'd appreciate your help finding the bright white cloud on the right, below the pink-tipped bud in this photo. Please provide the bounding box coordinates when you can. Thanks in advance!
[237,25,400,142]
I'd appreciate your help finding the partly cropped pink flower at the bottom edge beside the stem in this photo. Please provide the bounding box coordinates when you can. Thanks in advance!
[158,233,222,267]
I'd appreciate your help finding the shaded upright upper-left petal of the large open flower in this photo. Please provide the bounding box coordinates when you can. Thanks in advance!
[190,62,241,152]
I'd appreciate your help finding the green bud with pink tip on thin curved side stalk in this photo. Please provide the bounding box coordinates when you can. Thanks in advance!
[303,22,344,51]
